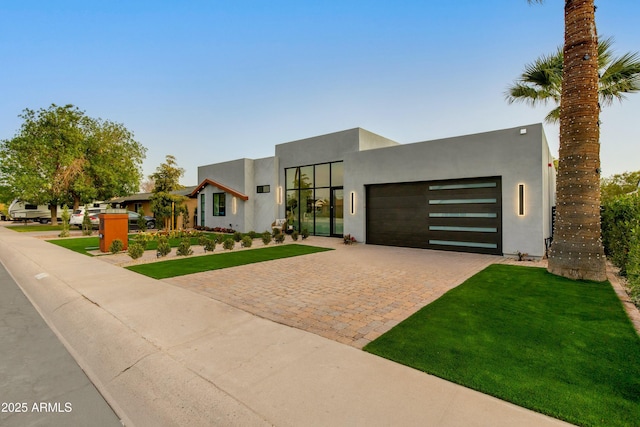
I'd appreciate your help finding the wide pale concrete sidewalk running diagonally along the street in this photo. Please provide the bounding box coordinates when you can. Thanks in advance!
[0,227,566,426]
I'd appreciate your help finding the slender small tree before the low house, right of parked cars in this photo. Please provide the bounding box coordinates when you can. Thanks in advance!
[149,155,186,228]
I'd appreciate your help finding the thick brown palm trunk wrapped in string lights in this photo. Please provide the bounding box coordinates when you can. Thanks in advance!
[548,0,606,281]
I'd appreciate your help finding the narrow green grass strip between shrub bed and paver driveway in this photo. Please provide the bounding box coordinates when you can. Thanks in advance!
[126,244,331,279]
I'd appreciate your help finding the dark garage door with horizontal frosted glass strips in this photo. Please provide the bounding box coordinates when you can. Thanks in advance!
[366,177,502,255]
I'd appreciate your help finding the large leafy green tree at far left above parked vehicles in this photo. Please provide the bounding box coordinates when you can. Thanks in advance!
[0,104,146,224]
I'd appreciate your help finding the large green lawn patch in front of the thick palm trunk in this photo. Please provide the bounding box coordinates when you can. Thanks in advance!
[364,265,640,426]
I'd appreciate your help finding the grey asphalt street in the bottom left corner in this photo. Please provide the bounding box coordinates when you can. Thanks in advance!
[0,264,122,427]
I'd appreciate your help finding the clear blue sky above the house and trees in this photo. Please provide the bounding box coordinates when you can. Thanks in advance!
[0,0,640,185]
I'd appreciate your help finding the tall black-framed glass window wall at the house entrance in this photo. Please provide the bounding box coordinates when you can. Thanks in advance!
[285,162,344,236]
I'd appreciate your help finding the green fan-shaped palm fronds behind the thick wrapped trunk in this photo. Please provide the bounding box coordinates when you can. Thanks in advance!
[505,38,640,123]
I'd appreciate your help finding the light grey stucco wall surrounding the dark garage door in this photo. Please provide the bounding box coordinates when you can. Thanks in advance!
[344,124,550,256]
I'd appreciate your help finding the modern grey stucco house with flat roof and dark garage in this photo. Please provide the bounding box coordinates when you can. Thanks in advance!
[191,124,555,257]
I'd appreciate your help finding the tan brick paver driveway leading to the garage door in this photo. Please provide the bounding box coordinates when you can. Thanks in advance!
[164,237,502,348]
